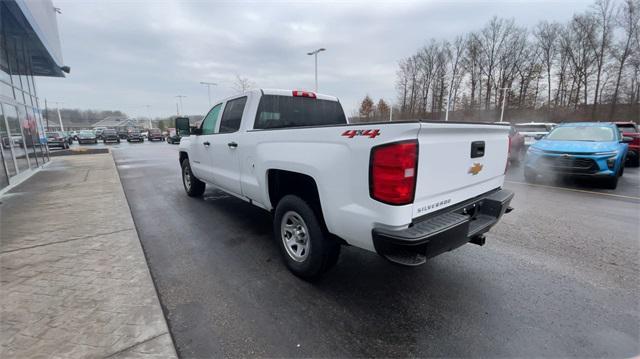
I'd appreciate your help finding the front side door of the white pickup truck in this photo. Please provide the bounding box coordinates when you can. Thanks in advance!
[189,103,222,183]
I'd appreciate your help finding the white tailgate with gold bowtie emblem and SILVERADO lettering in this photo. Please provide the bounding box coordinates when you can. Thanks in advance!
[413,123,509,218]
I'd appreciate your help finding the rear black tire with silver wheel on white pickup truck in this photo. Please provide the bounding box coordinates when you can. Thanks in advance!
[273,195,340,280]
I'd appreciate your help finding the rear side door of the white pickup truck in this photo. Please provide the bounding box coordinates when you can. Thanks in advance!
[209,96,247,195]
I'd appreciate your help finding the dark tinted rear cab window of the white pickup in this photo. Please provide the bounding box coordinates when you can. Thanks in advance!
[253,95,347,129]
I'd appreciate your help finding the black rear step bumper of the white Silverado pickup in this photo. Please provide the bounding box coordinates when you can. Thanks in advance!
[372,189,514,265]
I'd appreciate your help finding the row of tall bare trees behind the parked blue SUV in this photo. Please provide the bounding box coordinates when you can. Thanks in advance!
[363,0,640,121]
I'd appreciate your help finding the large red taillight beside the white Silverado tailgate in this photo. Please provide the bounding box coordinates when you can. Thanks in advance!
[369,140,418,205]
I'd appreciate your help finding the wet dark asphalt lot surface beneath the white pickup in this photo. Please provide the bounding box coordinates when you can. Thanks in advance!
[113,142,640,358]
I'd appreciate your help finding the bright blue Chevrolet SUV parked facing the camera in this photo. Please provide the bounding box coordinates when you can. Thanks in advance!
[524,122,632,189]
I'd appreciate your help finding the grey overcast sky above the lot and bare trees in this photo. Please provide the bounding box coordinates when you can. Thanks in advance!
[38,0,592,117]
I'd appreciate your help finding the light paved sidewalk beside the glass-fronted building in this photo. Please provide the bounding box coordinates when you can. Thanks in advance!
[0,154,176,358]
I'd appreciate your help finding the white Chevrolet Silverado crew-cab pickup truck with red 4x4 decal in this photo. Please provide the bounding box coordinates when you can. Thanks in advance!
[176,89,513,279]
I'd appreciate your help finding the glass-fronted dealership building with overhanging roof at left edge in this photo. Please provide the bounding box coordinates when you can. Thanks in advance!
[0,0,69,191]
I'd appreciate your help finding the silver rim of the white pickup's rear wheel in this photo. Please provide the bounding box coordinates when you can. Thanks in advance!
[280,211,311,262]
